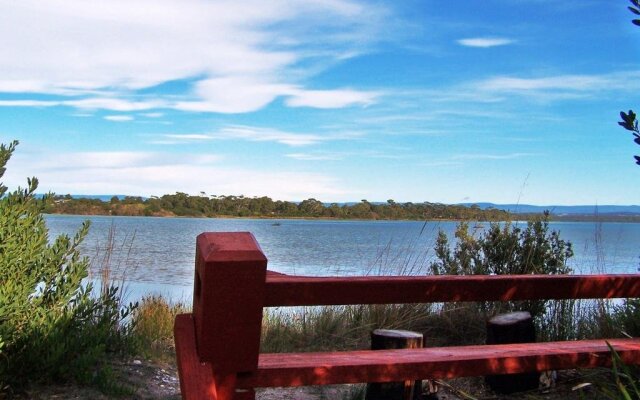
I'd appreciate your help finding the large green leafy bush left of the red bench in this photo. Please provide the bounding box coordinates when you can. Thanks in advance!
[0,142,135,390]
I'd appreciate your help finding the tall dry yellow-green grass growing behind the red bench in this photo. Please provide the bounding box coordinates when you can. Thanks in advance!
[126,297,640,399]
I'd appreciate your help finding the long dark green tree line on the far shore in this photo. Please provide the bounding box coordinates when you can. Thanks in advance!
[46,192,510,221]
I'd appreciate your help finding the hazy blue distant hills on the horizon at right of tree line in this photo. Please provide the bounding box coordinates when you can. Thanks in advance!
[460,203,640,215]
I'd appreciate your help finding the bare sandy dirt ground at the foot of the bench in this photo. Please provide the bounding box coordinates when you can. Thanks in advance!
[13,359,604,400]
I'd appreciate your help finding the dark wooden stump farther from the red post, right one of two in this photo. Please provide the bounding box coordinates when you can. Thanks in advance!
[485,311,540,394]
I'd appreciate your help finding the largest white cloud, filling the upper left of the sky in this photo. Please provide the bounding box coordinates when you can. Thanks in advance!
[0,0,386,113]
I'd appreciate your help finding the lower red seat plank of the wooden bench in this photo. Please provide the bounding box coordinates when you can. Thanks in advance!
[238,339,640,387]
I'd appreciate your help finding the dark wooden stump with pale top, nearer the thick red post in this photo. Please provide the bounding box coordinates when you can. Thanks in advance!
[365,329,422,400]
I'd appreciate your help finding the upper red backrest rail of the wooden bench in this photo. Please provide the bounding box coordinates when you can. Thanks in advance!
[264,274,640,307]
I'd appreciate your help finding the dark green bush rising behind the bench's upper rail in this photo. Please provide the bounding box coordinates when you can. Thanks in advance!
[431,213,573,317]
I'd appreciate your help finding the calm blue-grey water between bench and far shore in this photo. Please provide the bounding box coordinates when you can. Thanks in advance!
[46,215,640,300]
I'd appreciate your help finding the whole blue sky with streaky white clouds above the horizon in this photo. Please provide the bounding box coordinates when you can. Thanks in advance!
[0,0,640,205]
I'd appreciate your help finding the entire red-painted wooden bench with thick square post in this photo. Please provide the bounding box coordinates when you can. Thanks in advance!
[175,232,640,400]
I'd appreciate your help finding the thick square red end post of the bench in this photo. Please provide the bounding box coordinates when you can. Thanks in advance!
[193,232,267,399]
